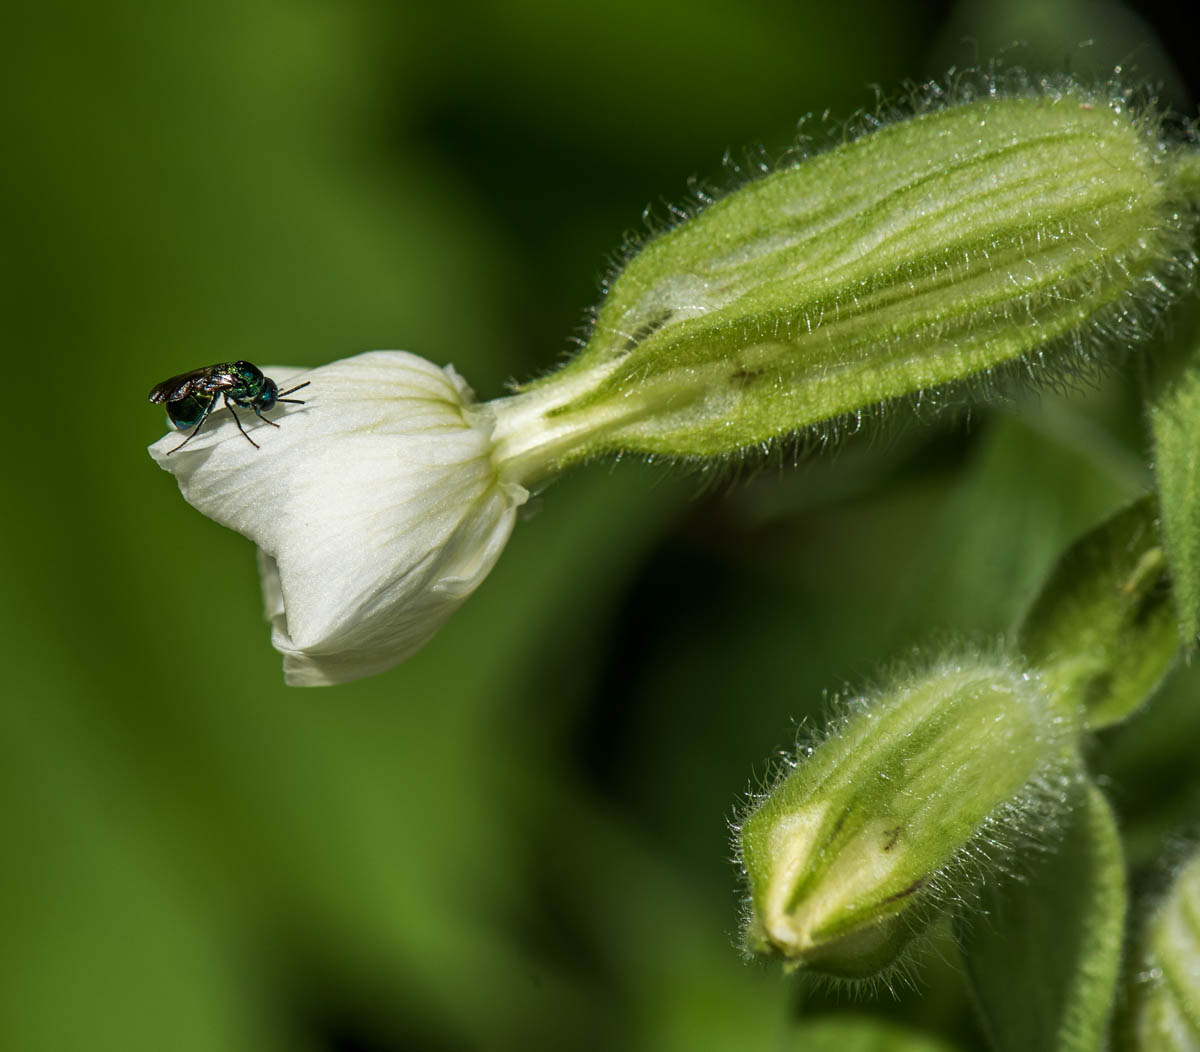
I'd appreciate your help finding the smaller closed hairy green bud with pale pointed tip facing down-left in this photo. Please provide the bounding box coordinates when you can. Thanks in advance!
[738,660,1075,978]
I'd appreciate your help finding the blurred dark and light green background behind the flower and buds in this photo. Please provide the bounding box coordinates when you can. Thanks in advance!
[7,0,1200,1052]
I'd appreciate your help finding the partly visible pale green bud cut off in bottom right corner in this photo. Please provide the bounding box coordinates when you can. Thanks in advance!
[1133,854,1200,1052]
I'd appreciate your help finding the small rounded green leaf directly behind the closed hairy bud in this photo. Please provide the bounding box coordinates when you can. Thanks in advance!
[1018,497,1178,729]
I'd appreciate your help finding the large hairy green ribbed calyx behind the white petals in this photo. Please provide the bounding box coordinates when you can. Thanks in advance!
[492,85,1196,467]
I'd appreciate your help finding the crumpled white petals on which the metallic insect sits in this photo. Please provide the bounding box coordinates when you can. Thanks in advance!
[150,351,529,686]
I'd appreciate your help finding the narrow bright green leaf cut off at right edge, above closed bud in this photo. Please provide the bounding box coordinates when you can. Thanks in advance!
[1150,338,1200,647]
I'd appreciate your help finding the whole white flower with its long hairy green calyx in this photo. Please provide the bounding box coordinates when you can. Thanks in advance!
[151,80,1200,684]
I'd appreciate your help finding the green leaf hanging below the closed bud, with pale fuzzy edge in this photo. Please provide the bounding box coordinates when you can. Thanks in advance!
[962,785,1126,1052]
